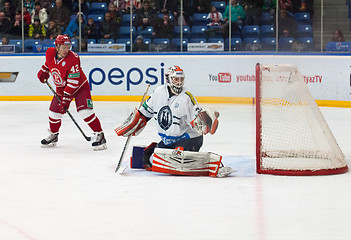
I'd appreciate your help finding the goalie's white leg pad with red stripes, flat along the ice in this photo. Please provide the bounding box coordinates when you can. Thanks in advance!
[152,148,222,177]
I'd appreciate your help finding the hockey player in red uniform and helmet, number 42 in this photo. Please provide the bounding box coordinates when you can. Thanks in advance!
[38,35,106,150]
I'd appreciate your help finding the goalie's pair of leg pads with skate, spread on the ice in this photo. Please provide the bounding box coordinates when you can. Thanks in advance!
[130,143,234,177]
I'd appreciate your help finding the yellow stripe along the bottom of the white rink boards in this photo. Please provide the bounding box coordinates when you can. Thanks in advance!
[0,96,351,108]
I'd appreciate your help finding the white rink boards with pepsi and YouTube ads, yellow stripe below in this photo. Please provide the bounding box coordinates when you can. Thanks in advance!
[0,53,351,107]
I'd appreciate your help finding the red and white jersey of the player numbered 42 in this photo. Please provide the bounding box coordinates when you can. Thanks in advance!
[41,47,87,96]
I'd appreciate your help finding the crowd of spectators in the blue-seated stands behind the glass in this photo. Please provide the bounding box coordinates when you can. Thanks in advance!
[0,0,313,51]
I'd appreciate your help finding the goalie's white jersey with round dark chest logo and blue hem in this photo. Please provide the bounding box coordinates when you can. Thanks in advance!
[139,85,202,145]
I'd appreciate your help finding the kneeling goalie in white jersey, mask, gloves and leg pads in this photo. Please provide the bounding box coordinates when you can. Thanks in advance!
[115,66,233,177]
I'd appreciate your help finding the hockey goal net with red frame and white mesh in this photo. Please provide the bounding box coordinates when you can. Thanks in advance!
[256,64,348,175]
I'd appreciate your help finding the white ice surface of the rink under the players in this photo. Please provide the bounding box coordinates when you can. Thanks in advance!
[0,101,351,240]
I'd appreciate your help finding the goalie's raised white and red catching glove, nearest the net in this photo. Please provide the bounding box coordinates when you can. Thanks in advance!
[191,109,219,135]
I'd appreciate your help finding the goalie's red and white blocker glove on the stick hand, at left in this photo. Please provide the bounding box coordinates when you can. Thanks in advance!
[115,108,146,137]
